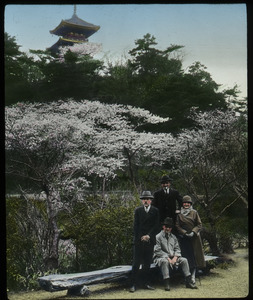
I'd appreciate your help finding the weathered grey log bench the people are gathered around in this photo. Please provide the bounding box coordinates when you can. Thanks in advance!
[38,255,218,296]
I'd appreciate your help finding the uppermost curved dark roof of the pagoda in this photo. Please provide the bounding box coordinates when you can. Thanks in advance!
[50,13,100,38]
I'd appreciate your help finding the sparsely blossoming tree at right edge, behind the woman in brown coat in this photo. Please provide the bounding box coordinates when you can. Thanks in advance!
[174,110,248,254]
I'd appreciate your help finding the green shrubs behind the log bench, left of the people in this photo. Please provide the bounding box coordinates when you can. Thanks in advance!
[6,195,140,290]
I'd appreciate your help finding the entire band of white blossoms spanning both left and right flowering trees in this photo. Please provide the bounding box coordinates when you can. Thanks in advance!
[5,99,245,214]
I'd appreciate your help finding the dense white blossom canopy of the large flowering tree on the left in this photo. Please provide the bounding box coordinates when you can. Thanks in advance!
[5,99,173,190]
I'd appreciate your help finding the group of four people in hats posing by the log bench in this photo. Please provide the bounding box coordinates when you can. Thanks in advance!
[129,175,205,292]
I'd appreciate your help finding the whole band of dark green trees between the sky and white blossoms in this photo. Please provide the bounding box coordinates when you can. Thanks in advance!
[5,33,232,133]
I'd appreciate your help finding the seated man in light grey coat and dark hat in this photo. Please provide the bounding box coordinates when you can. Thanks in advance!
[154,217,197,291]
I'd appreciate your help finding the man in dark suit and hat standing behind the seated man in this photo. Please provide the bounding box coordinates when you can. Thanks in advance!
[152,175,182,224]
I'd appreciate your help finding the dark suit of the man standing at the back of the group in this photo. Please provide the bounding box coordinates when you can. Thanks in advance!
[152,188,182,224]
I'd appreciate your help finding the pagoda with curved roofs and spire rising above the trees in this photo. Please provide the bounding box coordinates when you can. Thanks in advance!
[48,5,100,53]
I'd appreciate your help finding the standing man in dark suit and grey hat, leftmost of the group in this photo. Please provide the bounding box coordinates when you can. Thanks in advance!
[129,191,159,292]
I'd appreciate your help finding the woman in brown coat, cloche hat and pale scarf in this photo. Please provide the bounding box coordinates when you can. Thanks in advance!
[175,195,206,282]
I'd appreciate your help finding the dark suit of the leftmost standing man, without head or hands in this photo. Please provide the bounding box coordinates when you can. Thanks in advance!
[132,205,159,284]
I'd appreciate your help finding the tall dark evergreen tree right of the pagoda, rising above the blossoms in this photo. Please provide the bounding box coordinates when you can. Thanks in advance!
[99,33,230,134]
